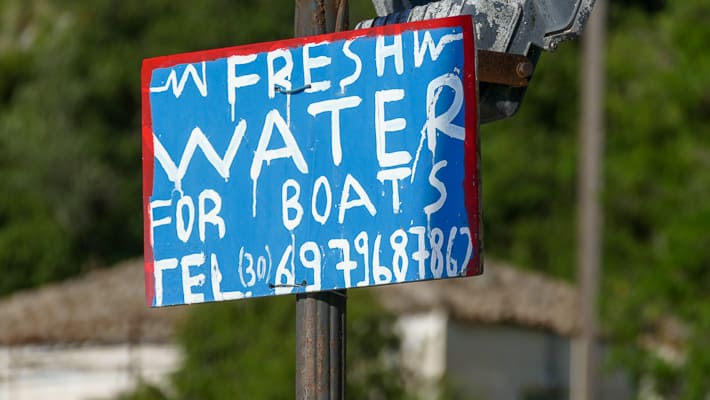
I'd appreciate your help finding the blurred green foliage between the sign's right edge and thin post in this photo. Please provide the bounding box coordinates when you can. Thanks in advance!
[481,43,578,279]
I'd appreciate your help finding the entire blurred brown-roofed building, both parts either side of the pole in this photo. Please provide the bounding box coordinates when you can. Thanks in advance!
[0,260,632,400]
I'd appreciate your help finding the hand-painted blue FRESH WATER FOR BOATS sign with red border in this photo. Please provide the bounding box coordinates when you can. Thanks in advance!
[142,17,481,306]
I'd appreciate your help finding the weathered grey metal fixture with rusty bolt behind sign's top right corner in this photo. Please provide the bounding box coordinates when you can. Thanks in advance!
[358,0,595,123]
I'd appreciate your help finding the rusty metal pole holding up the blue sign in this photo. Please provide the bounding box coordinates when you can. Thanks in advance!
[294,0,348,400]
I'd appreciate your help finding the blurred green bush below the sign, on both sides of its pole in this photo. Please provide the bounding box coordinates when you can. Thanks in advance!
[119,290,406,400]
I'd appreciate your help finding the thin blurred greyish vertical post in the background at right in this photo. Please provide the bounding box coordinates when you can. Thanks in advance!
[570,0,606,400]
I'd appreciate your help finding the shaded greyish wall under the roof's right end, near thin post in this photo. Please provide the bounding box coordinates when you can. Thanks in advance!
[447,321,633,400]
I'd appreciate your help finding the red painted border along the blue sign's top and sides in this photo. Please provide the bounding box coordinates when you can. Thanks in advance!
[141,16,483,305]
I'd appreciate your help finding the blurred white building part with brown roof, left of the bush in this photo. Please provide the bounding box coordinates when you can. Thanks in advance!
[0,261,184,400]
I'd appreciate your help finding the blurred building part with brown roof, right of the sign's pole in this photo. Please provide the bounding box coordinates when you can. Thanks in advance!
[375,266,633,400]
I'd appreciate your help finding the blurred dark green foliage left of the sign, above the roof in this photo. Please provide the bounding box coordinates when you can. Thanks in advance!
[0,0,371,295]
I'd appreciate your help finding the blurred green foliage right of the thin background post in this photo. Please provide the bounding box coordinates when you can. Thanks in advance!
[604,1,710,399]
